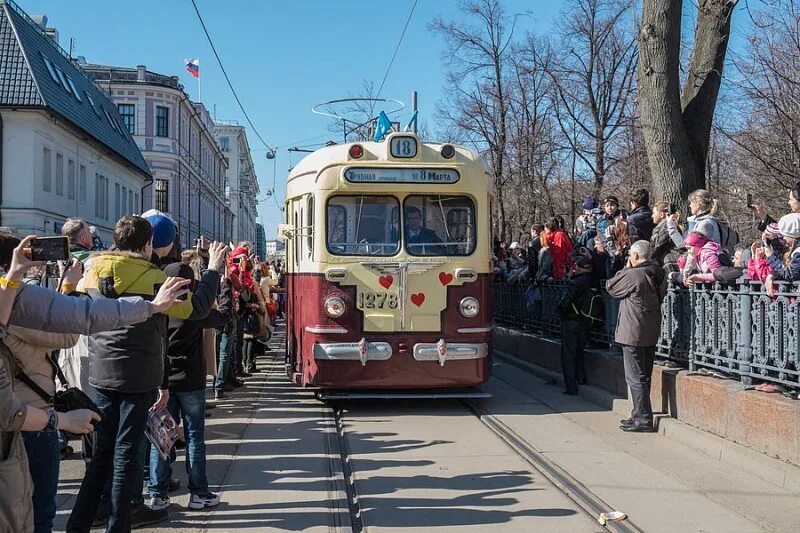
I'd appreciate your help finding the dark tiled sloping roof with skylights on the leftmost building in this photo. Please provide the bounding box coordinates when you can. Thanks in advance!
[0,0,151,176]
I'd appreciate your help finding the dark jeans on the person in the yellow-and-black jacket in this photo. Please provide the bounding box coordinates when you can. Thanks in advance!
[67,389,157,533]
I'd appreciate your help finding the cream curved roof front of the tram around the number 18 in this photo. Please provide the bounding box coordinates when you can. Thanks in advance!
[287,133,484,181]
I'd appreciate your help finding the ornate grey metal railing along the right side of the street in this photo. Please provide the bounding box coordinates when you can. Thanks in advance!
[494,280,800,388]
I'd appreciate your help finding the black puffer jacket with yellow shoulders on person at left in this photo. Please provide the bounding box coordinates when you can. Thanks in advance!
[78,252,192,394]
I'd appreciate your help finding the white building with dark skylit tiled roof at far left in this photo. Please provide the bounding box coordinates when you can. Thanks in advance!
[0,2,151,245]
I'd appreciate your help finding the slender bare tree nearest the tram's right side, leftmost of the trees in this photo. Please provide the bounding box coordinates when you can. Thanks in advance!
[431,0,514,240]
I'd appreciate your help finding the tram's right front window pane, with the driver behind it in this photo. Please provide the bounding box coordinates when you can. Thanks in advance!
[403,194,475,256]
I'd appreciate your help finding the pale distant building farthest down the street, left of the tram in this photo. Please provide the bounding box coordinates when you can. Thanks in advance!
[214,120,259,244]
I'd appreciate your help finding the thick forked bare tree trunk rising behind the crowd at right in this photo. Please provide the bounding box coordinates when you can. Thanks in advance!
[638,0,737,208]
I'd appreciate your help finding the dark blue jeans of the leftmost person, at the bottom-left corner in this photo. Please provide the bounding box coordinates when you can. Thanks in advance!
[22,431,61,533]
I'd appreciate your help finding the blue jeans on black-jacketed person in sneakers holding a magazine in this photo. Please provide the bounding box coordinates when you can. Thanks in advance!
[150,389,208,498]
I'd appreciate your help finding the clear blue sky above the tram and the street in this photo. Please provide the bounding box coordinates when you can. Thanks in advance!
[16,0,756,239]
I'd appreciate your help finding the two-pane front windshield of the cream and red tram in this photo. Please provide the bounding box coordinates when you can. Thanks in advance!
[327,194,475,256]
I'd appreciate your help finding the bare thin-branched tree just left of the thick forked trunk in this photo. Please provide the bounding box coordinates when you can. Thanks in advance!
[550,0,637,194]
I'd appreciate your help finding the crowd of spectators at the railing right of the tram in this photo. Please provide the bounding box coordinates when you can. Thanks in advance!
[495,183,800,431]
